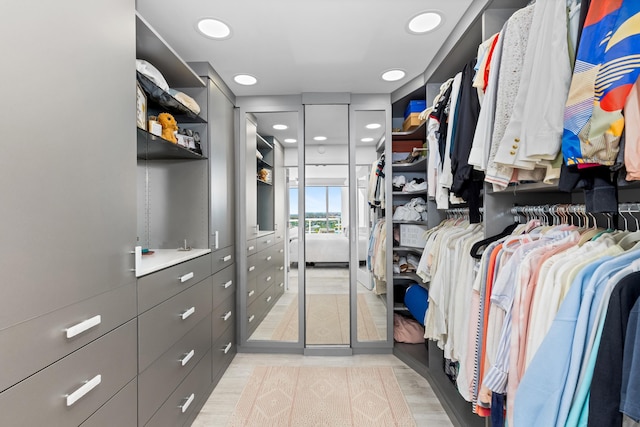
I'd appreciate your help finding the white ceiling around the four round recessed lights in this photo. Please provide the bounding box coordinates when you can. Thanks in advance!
[137,0,477,96]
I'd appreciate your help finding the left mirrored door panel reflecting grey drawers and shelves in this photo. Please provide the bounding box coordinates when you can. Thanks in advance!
[246,112,298,342]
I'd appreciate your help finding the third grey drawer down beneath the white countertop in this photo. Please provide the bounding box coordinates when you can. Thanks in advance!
[138,315,211,425]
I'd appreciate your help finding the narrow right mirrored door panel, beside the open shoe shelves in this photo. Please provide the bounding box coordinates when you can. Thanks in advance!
[352,110,387,342]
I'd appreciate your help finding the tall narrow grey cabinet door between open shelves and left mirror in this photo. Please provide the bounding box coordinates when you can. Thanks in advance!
[209,82,236,250]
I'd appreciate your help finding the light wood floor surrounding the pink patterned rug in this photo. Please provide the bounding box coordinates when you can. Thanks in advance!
[193,354,453,427]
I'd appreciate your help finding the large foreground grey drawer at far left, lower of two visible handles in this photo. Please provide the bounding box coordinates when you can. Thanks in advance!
[0,320,136,426]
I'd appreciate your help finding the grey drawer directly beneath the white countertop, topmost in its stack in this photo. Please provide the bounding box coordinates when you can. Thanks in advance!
[138,254,211,313]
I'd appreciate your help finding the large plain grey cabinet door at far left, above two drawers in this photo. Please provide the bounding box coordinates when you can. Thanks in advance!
[0,0,136,338]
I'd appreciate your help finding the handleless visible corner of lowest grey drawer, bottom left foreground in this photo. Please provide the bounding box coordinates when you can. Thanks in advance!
[80,379,138,427]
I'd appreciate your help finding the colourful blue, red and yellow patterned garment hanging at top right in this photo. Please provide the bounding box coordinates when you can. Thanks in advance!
[562,0,640,167]
